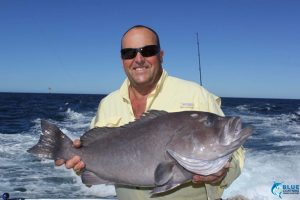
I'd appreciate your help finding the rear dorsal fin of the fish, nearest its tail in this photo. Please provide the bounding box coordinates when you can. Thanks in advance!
[80,127,115,146]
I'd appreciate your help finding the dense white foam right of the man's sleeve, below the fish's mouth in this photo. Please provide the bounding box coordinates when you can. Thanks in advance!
[223,152,300,200]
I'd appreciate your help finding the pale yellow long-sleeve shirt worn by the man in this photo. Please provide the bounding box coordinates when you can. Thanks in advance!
[91,71,244,200]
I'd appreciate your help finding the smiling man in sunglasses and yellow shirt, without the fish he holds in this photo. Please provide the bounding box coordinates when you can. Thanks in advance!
[56,25,244,200]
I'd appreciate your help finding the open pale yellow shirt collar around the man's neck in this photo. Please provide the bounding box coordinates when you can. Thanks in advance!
[119,69,168,102]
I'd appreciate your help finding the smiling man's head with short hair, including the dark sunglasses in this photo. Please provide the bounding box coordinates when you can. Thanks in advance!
[121,25,163,88]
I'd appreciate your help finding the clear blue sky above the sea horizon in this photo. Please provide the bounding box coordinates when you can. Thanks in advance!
[0,0,300,99]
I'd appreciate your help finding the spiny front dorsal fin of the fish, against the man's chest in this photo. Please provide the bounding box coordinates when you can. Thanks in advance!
[121,110,168,128]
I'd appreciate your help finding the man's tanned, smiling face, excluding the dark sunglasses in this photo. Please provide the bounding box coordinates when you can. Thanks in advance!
[122,28,163,87]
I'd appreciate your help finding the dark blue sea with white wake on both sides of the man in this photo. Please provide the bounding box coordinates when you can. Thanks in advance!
[0,93,300,200]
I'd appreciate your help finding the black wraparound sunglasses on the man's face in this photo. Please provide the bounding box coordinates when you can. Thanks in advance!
[121,45,160,60]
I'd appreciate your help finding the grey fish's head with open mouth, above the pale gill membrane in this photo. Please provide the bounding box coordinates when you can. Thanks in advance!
[167,112,251,160]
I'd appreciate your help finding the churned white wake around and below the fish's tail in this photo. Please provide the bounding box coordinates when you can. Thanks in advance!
[0,125,115,198]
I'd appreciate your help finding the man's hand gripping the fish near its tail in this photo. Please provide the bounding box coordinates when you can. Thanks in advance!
[55,139,85,172]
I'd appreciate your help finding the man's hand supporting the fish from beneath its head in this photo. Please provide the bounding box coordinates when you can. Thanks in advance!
[193,162,230,185]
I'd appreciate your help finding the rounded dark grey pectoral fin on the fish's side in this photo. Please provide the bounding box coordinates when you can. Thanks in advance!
[154,162,174,186]
